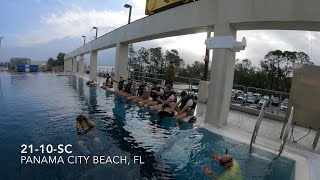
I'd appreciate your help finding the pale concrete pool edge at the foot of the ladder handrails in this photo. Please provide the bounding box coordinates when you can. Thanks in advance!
[203,123,320,180]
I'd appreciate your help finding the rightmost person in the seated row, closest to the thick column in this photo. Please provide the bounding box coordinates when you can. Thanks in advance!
[170,91,197,121]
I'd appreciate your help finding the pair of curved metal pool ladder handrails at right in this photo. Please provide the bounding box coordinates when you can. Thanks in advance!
[249,101,294,160]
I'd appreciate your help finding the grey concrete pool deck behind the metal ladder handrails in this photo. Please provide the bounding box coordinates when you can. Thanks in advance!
[79,75,320,180]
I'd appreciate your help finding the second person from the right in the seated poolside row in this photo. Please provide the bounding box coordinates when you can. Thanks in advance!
[150,84,176,111]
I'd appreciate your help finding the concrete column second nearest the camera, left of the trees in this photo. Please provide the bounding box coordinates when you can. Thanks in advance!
[115,43,129,88]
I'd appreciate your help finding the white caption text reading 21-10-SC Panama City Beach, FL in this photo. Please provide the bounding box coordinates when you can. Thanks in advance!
[20,144,144,165]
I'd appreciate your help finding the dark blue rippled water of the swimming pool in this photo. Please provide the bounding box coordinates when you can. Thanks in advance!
[0,73,295,180]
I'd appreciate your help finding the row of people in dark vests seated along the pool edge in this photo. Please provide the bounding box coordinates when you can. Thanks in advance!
[114,77,196,120]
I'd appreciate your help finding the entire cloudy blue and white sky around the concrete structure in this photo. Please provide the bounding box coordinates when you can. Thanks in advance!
[0,0,320,65]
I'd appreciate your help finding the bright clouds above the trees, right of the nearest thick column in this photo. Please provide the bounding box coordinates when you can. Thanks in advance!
[237,30,320,65]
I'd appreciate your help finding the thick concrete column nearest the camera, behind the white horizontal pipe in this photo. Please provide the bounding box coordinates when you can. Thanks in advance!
[205,24,237,126]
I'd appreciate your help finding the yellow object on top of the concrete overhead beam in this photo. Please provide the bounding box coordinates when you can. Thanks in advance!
[145,0,192,15]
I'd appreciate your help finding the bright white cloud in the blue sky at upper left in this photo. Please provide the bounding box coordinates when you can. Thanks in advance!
[15,9,127,46]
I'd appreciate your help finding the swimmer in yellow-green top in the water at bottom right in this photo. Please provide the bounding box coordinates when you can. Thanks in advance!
[204,149,243,180]
